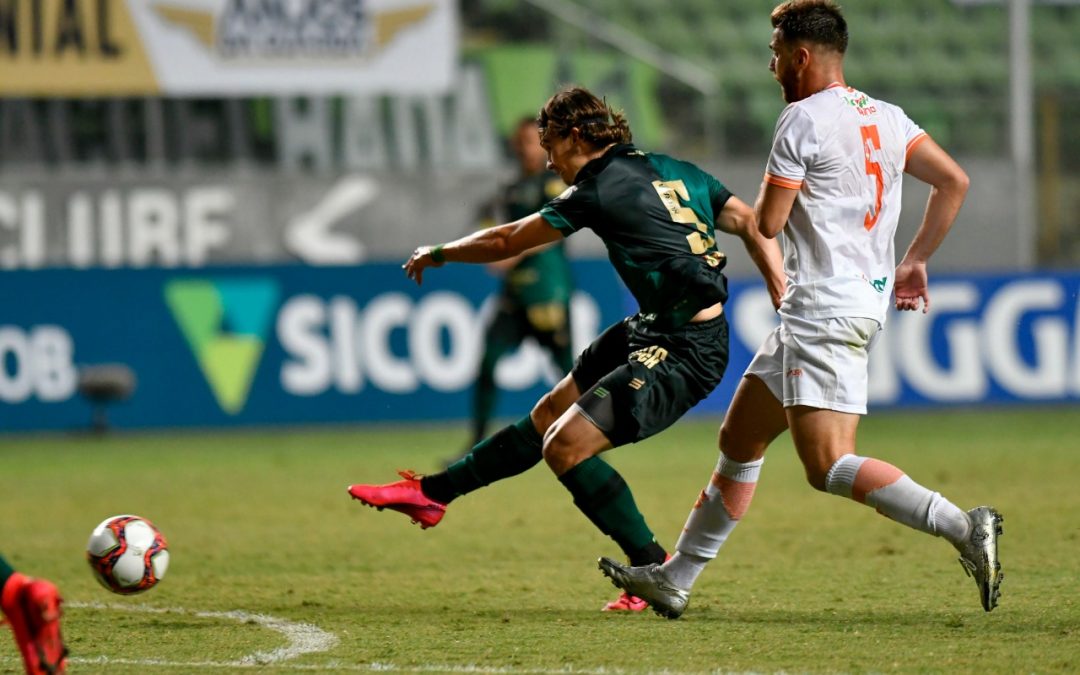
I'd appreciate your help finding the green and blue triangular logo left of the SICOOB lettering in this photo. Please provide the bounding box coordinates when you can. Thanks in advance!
[165,278,279,415]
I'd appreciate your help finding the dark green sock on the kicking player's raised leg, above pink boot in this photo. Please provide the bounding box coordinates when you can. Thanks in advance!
[420,416,543,504]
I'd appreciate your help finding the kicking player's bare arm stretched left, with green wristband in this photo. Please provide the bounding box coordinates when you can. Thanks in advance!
[402,213,563,284]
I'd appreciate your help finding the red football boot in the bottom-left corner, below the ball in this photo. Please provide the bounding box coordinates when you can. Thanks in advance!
[0,555,67,675]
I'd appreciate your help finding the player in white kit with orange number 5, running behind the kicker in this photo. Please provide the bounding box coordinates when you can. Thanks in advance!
[599,0,1002,619]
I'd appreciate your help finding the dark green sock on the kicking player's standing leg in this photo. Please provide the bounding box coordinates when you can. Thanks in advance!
[558,457,666,565]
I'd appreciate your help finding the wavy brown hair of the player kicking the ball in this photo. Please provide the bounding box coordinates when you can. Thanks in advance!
[537,86,633,148]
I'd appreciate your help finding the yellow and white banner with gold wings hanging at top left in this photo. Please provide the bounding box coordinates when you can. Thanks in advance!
[0,0,458,96]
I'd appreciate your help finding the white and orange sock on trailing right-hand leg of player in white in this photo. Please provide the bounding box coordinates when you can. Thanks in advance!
[825,455,971,545]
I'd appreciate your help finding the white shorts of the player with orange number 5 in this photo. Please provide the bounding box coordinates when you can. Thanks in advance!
[745,315,881,415]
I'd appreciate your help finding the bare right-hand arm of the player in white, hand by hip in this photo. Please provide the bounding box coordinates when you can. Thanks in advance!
[893,138,970,313]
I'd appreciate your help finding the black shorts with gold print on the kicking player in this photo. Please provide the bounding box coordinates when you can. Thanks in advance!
[572,314,728,447]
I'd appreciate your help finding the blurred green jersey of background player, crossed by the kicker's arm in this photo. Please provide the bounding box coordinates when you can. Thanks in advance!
[495,172,573,306]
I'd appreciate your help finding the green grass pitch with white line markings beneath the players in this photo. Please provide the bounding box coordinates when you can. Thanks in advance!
[0,408,1080,673]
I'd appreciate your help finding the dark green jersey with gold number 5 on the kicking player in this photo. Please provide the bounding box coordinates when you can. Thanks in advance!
[540,145,731,328]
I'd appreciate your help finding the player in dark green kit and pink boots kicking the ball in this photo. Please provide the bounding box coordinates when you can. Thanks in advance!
[349,87,785,611]
